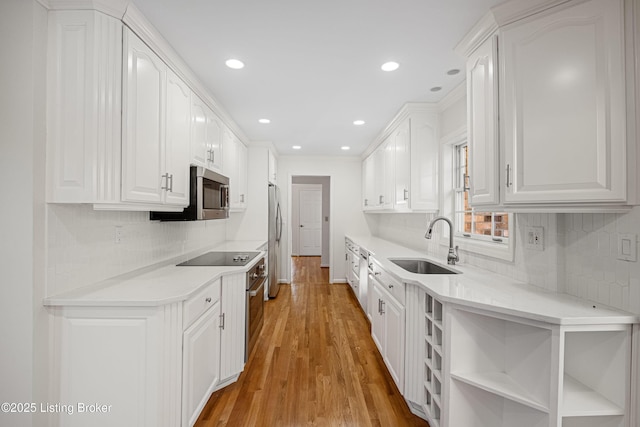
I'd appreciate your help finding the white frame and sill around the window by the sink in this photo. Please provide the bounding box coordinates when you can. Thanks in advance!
[439,126,515,261]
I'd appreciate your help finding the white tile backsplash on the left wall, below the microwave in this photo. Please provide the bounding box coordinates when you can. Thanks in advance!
[47,204,226,295]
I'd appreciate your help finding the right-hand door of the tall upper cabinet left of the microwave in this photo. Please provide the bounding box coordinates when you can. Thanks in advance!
[164,70,191,206]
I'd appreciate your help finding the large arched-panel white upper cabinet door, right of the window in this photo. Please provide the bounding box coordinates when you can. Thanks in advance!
[500,0,626,203]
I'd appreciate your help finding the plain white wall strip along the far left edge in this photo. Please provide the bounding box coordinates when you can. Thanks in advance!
[0,0,47,427]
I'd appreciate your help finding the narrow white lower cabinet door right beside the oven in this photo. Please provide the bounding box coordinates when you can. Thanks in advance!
[220,273,246,381]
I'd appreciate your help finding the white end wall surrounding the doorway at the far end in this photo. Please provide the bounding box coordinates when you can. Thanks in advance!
[278,156,369,282]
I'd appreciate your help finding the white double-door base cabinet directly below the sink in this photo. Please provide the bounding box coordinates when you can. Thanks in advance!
[369,275,405,391]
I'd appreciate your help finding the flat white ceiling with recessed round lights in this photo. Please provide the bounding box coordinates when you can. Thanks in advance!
[133,0,502,156]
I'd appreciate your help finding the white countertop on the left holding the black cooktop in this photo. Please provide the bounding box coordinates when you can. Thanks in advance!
[44,241,266,307]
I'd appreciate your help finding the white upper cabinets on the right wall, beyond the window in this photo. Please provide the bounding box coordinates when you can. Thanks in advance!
[362,104,439,212]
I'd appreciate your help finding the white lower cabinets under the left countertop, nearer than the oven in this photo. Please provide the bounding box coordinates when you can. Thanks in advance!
[50,273,246,427]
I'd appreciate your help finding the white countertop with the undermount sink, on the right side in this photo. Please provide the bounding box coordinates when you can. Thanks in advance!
[346,235,640,325]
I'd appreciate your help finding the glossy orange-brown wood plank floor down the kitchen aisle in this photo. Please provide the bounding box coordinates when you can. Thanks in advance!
[196,257,428,427]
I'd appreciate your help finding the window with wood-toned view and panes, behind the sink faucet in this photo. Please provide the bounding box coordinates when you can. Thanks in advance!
[453,142,509,244]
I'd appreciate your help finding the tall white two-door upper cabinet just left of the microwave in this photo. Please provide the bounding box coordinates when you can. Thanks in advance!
[122,30,191,206]
